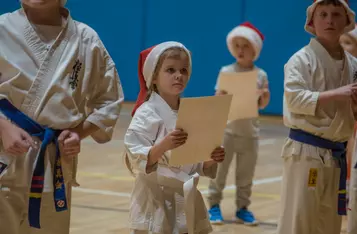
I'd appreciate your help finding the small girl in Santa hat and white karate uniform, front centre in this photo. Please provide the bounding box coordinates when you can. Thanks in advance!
[124,42,225,234]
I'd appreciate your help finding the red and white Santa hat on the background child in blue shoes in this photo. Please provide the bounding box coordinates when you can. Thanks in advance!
[227,22,264,60]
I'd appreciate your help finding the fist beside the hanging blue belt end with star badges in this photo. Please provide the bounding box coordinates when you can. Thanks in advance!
[58,130,81,158]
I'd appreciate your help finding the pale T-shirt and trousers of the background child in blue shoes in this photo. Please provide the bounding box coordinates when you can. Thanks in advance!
[208,63,268,210]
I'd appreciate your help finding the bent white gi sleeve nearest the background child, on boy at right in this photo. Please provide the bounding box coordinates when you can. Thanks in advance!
[284,55,319,116]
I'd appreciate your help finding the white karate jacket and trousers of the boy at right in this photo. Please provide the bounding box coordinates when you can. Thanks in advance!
[278,39,357,234]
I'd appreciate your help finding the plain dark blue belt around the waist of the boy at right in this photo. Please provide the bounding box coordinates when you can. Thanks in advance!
[289,129,347,215]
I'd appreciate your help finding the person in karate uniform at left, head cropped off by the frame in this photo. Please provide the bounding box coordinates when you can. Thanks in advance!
[0,0,124,234]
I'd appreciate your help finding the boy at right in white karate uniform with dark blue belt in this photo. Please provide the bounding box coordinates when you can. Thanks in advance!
[278,0,357,234]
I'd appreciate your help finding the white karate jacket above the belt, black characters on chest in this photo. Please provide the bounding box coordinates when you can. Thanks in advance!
[0,9,124,143]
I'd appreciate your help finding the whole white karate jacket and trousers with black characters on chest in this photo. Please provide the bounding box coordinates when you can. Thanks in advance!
[0,9,124,234]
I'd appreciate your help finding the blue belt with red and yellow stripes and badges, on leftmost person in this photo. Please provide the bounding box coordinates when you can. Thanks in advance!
[0,99,67,228]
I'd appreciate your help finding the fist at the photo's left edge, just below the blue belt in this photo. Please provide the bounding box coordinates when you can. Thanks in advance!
[0,120,37,156]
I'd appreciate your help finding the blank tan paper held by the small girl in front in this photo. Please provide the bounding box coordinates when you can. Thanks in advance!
[169,95,232,166]
